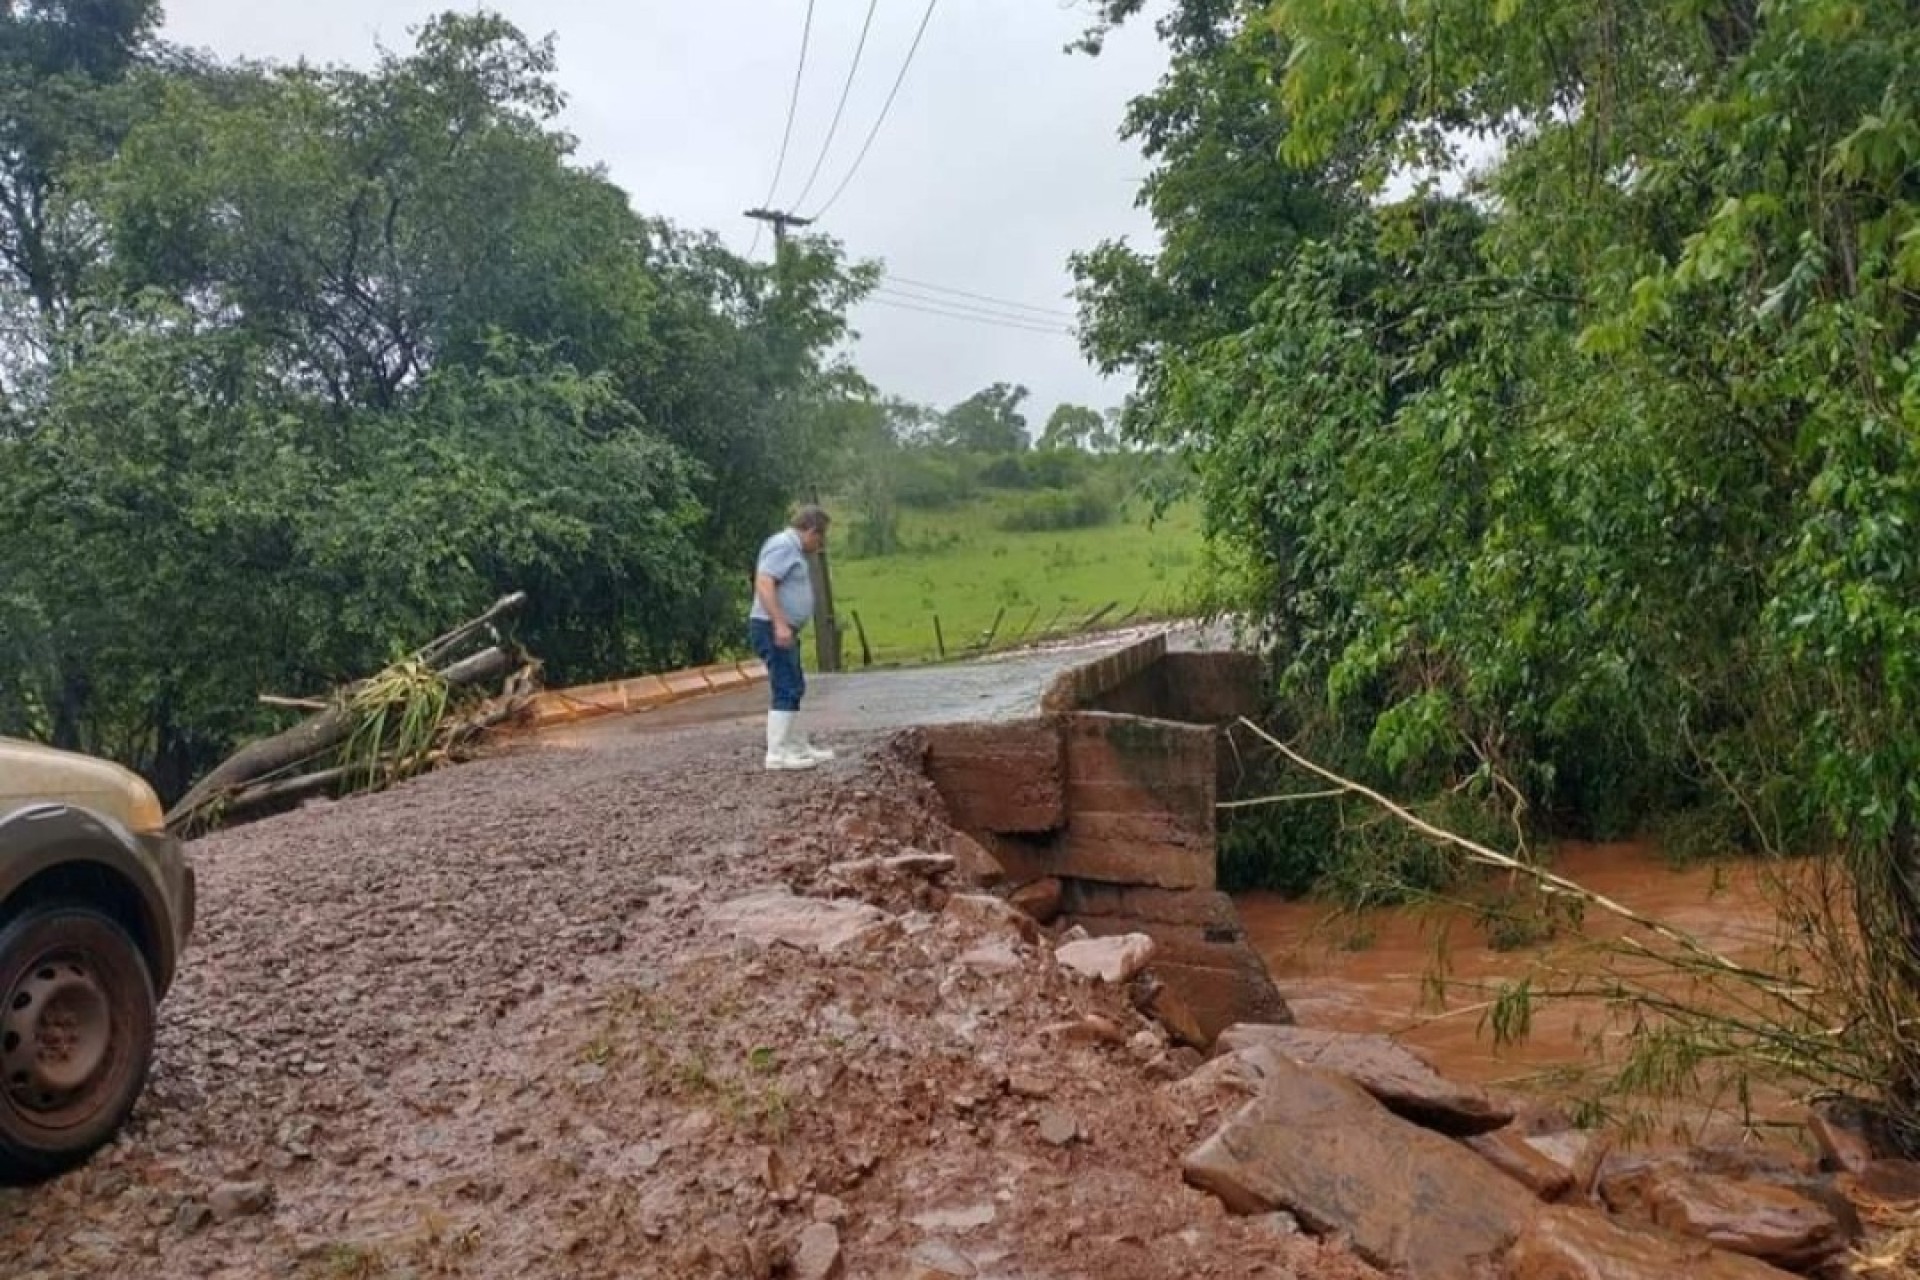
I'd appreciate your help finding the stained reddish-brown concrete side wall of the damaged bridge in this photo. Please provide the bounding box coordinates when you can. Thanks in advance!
[924,637,1292,1048]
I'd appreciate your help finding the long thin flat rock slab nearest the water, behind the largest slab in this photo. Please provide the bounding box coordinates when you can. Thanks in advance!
[1215,1023,1513,1136]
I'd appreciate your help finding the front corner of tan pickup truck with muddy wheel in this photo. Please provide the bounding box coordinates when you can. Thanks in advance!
[0,739,194,1182]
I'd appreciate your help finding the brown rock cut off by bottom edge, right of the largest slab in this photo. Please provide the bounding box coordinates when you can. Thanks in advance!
[1505,1205,1791,1280]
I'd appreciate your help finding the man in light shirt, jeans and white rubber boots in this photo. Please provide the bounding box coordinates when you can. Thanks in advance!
[747,507,833,770]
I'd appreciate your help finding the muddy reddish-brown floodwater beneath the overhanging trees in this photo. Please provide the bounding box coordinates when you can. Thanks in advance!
[1236,844,1795,1121]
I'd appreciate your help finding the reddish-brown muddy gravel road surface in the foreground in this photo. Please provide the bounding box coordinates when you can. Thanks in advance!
[0,722,1371,1280]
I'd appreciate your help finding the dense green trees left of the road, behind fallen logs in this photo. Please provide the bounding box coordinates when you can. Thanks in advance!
[0,0,874,793]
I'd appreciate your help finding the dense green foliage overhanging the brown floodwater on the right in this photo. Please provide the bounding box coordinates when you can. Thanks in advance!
[1079,0,1920,1120]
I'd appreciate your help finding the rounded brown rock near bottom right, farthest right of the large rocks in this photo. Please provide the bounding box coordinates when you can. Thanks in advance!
[1599,1163,1849,1268]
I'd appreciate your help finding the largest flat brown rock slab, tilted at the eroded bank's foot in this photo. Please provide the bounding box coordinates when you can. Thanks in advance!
[1185,1046,1540,1280]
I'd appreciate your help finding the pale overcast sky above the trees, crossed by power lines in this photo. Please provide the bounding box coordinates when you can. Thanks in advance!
[165,0,1165,428]
